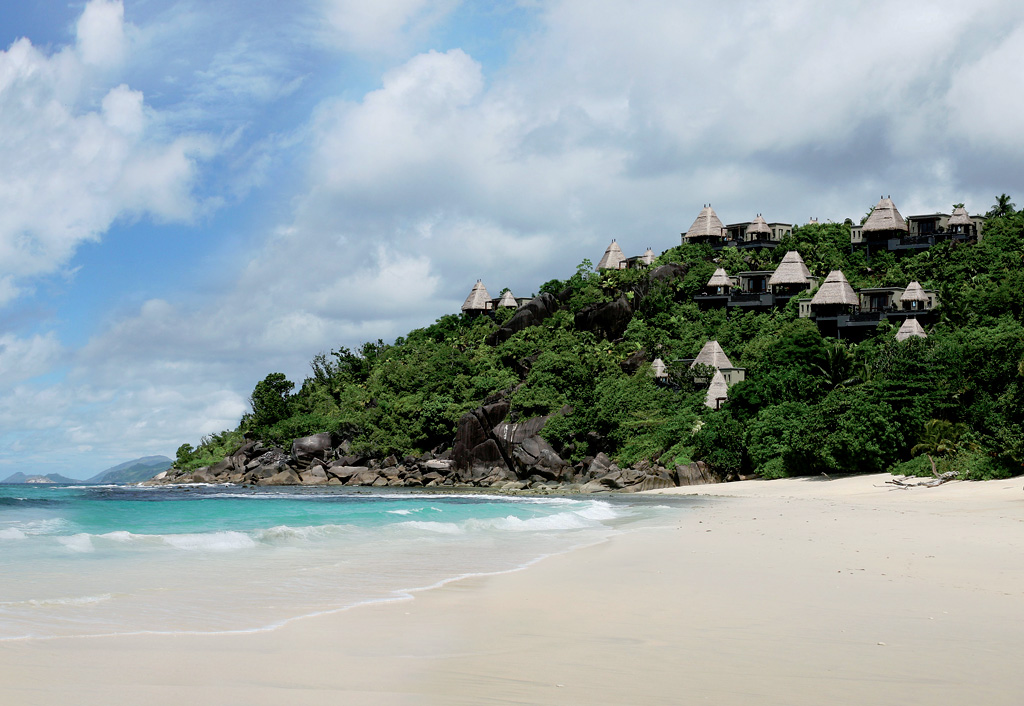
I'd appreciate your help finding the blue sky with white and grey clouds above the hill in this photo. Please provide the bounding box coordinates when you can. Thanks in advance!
[0,0,1024,477]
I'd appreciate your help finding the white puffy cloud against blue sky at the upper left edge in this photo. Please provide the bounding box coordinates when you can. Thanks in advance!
[0,0,212,303]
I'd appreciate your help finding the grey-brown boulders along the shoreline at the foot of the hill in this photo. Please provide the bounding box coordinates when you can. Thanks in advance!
[146,426,724,493]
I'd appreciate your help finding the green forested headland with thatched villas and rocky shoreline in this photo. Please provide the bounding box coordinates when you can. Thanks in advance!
[155,194,1024,492]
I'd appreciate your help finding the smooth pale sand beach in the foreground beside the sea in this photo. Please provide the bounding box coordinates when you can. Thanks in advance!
[0,475,1024,706]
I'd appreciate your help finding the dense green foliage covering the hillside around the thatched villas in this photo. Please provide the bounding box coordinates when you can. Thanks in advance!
[177,196,1024,479]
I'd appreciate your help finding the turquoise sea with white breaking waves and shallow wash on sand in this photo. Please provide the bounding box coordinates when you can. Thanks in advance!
[0,485,680,640]
